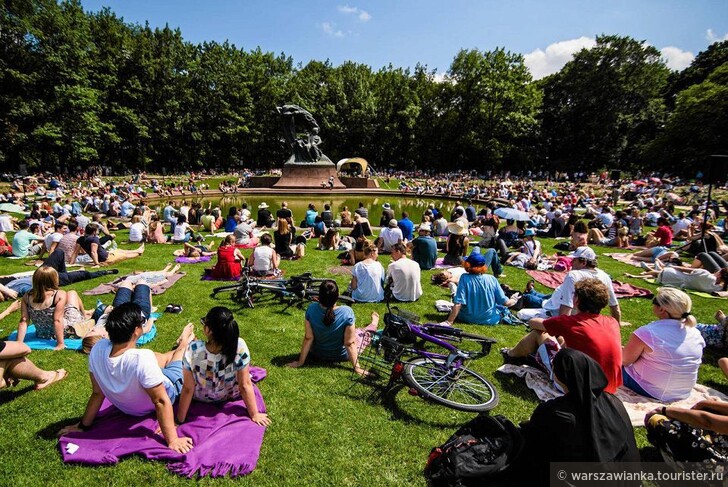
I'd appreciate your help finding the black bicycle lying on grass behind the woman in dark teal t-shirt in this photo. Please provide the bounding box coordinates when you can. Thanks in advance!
[210,266,354,310]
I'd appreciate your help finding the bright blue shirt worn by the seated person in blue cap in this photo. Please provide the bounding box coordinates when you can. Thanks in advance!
[453,274,507,325]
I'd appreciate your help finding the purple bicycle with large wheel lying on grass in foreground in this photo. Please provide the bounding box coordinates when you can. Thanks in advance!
[357,304,499,412]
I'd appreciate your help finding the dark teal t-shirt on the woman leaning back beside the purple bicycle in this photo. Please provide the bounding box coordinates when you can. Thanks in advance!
[306,303,354,362]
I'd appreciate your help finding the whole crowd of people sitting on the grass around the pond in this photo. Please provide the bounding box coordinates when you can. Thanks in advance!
[0,174,728,480]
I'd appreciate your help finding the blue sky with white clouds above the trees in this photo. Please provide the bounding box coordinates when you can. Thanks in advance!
[82,0,728,79]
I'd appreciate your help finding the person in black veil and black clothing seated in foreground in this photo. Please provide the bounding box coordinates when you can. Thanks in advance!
[512,348,640,485]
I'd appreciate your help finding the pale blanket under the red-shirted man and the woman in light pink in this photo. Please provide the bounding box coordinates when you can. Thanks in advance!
[497,364,728,427]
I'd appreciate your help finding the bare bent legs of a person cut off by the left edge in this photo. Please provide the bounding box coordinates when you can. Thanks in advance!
[0,340,68,391]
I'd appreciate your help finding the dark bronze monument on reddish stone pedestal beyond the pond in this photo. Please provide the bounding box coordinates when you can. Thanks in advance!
[273,105,346,189]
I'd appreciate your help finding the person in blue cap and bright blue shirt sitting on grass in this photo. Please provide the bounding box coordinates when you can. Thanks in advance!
[446,253,518,325]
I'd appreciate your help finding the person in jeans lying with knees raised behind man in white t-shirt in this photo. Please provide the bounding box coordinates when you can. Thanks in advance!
[81,277,155,353]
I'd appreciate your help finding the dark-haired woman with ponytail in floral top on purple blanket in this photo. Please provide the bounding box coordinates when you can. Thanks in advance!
[176,306,270,426]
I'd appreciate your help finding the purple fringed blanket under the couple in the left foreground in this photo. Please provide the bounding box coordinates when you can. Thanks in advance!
[58,367,266,478]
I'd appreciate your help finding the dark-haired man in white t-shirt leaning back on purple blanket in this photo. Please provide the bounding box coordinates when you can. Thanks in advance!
[60,303,195,453]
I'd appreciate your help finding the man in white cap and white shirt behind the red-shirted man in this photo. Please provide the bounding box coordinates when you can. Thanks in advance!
[518,246,622,322]
